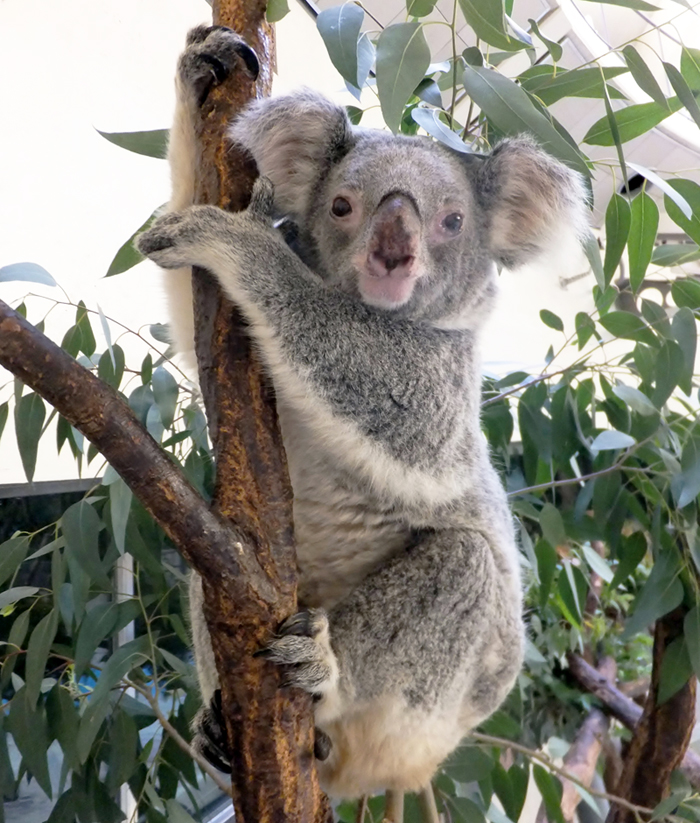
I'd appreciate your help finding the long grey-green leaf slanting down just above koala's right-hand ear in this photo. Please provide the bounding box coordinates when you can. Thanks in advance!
[463,66,590,177]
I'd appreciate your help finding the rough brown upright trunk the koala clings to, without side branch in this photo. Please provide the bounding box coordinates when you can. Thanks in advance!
[183,0,331,823]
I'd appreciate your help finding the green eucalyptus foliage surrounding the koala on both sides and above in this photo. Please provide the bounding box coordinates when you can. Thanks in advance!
[0,0,700,823]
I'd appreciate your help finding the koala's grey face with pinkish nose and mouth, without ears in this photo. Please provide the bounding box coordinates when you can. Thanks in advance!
[307,132,494,323]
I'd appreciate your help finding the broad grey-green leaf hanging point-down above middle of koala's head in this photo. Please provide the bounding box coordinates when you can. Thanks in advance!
[377,23,430,134]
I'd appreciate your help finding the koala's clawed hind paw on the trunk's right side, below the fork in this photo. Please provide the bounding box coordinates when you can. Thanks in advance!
[258,609,338,698]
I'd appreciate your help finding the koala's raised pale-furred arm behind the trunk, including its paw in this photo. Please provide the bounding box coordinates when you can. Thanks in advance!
[164,26,258,374]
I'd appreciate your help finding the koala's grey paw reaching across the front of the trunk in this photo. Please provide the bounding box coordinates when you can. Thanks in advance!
[135,206,230,269]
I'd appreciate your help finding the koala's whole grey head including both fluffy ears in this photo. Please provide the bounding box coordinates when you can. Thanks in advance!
[232,91,586,327]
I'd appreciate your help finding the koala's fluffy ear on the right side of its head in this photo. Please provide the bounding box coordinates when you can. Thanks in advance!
[476,137,589,268]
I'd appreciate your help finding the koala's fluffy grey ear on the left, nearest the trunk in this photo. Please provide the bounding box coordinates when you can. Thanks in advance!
[229,89,353,216]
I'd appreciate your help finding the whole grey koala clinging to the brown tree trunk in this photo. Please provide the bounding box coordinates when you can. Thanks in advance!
[137,27,586,797]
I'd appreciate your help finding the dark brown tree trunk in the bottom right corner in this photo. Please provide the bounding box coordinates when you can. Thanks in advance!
[607,607,696,823]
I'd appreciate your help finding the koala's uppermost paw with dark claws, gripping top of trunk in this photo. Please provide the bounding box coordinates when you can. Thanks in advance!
[178,26,259,106]
